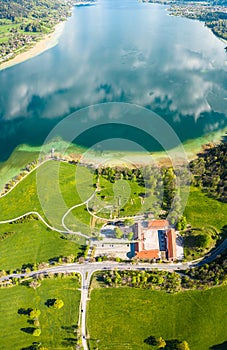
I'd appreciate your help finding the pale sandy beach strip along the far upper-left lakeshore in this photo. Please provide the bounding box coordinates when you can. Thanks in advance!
[0,22,65,70]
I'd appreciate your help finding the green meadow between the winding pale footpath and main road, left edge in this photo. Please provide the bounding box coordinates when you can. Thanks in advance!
[0,220,85,270]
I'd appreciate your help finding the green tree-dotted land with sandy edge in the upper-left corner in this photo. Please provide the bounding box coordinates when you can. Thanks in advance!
[0,0,94,70]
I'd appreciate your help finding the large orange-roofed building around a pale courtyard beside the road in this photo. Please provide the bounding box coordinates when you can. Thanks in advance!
[135,220,177,260]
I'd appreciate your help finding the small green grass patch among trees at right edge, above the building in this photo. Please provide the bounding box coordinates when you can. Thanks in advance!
[185,187,227,231]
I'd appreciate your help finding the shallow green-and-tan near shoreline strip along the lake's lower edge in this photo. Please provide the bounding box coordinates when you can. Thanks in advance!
[0,128,227,191]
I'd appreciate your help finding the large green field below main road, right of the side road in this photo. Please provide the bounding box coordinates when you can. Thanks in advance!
[88,286,227,350]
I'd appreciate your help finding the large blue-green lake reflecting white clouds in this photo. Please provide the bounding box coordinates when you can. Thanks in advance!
[0,0,227,162]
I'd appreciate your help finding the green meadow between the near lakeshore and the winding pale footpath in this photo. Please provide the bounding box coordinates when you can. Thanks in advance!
[0,161,94,229]
